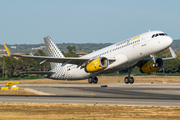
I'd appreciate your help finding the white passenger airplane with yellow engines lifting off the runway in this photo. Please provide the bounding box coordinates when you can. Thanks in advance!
[3,31,177,84]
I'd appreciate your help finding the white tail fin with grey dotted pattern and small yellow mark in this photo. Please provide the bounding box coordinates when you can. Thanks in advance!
[44,36,64,69]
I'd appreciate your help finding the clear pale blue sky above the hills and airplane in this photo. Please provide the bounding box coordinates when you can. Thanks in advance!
[0,0,180,44]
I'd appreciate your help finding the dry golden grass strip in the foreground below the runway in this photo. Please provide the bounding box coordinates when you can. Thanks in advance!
[0,103,180,120]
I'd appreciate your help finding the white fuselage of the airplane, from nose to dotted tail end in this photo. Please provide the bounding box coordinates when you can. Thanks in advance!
[50,31,173,80]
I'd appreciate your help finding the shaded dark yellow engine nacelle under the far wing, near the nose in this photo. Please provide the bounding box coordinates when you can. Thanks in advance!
[140,58,164,73]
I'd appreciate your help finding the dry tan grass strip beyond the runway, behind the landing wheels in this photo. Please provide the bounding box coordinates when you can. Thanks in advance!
[0,75,180,84]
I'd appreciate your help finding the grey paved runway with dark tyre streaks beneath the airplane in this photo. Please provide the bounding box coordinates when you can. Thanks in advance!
[0,83,180,107]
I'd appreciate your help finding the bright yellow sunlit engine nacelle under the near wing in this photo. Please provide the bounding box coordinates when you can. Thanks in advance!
[85,57,109,72]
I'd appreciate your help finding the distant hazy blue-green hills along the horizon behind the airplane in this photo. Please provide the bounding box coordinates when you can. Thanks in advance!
[0,40,180,54]
